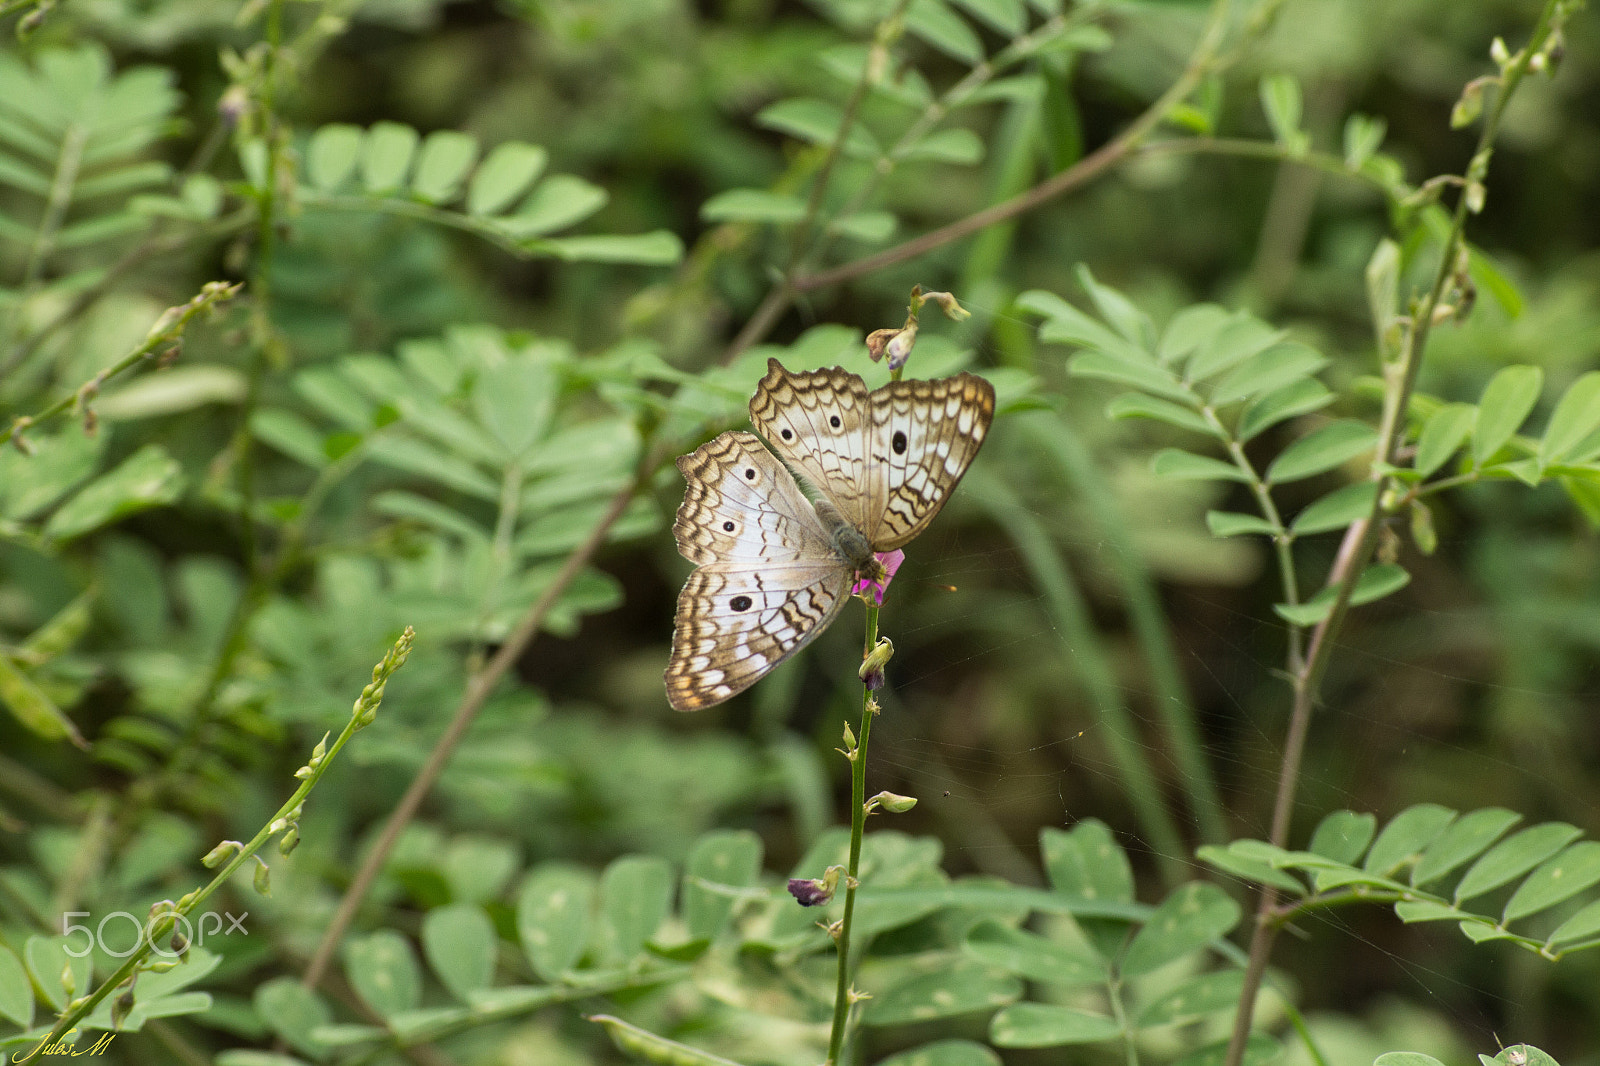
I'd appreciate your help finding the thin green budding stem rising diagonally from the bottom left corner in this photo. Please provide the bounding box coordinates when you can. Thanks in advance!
[14,626,416,1063]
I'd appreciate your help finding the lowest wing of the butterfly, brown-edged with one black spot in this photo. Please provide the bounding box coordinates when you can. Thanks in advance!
[667,559,853,711]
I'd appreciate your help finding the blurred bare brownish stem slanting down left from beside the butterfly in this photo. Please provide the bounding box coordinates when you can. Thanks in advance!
[301,435,664,988]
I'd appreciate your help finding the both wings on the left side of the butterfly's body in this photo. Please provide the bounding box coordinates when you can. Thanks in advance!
[666,432,851,711]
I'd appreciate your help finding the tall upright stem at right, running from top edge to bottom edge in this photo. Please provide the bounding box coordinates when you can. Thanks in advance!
[1224,8,1563,1066]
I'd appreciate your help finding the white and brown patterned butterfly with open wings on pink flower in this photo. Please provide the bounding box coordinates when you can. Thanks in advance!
[666,359,995,711]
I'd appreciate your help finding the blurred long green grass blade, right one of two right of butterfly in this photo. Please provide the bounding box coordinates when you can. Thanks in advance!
[1026,415,1229,844]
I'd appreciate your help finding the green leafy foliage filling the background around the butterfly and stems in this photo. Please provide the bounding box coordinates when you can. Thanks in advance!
[0,0,1600,1066]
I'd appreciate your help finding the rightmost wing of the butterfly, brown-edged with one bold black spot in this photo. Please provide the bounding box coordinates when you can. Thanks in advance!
[858,373,995,552]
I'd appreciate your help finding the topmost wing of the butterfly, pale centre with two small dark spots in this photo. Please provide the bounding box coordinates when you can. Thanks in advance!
[750,359,877,533]
